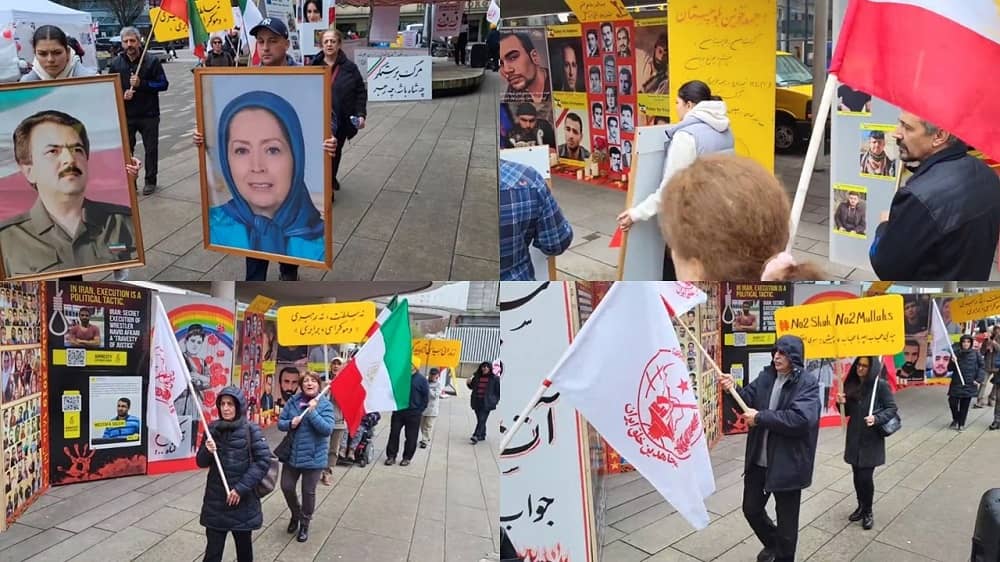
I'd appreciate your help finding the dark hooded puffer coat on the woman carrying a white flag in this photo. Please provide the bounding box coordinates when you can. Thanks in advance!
[196,386,271,531]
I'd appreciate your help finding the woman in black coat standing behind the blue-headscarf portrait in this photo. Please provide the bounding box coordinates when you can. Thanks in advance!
[312,29,368,190]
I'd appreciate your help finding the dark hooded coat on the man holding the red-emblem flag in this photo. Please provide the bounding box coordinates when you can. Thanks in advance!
[739,336,822,492]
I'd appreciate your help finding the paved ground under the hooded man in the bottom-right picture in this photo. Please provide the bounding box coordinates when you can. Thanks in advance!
[603,387,1000,562]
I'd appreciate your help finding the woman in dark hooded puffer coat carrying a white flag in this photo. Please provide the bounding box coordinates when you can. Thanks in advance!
[196,386,271,562]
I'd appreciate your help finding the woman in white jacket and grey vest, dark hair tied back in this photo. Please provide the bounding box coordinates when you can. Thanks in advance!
[618,80,734,281]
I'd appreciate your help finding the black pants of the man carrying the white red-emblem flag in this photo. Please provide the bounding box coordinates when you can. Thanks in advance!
[743,465,802,562]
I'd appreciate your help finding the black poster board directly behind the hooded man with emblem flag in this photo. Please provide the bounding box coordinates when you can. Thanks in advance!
[719,282,792,435]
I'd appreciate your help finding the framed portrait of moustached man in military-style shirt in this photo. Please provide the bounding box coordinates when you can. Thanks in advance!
[0,76,145,280]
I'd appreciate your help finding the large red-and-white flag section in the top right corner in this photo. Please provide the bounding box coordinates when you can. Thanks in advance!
[830,0,1000,158]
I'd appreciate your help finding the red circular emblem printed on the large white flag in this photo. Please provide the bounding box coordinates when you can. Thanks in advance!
[625,349,704,467]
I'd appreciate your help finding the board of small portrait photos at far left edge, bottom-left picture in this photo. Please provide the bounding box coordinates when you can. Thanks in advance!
[0,282,48,530]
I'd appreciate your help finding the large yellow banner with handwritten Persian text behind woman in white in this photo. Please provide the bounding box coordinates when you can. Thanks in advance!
[667,0,778,171]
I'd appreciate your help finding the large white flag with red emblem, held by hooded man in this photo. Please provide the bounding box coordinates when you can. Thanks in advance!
[549,282,715,529]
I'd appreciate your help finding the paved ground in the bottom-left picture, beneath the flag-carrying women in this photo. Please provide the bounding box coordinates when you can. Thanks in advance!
[0,395,500,562]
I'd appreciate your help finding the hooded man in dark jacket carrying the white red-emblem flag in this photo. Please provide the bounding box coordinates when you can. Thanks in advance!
[719,336,822,562]
